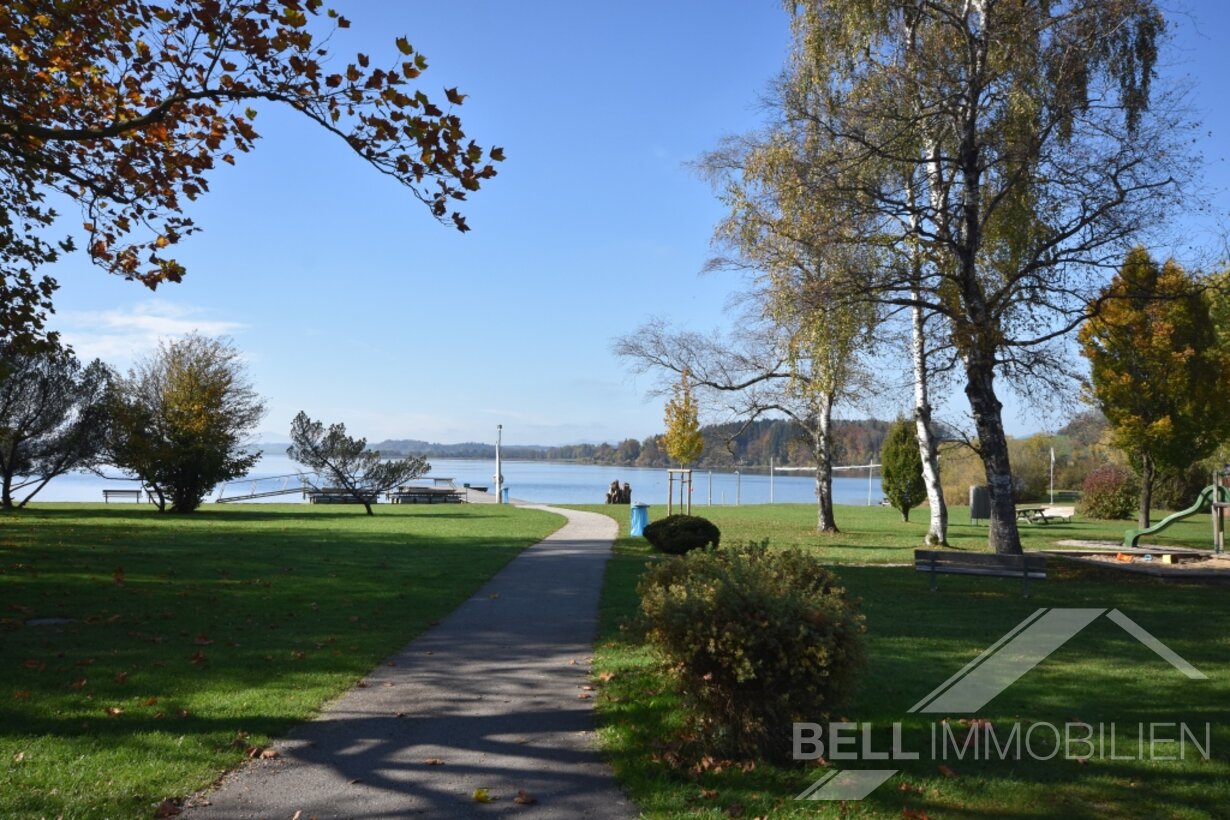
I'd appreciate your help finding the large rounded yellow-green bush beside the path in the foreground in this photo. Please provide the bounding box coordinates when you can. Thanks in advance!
[638,542,865,761]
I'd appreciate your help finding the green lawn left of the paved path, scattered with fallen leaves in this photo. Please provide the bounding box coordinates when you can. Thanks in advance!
[0,504,561,818]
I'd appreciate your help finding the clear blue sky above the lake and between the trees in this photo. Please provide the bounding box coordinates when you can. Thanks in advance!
[45,0,1230,444]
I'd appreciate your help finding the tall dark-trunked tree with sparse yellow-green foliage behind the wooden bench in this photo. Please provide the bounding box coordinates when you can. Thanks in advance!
[781,0,1189,553]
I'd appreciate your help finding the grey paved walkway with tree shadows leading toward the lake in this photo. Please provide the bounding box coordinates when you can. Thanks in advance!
[183,507,637,820]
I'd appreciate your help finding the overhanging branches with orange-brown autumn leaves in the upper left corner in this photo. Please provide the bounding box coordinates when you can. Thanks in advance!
[0,0,503,342]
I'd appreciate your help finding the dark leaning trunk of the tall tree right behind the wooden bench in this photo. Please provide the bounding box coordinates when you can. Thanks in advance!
[966,353,1021,554]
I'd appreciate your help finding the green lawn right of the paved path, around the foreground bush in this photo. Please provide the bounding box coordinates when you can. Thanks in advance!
[575,505,1230,818]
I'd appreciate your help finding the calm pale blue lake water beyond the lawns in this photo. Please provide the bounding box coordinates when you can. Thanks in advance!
[23,454,883,507]
